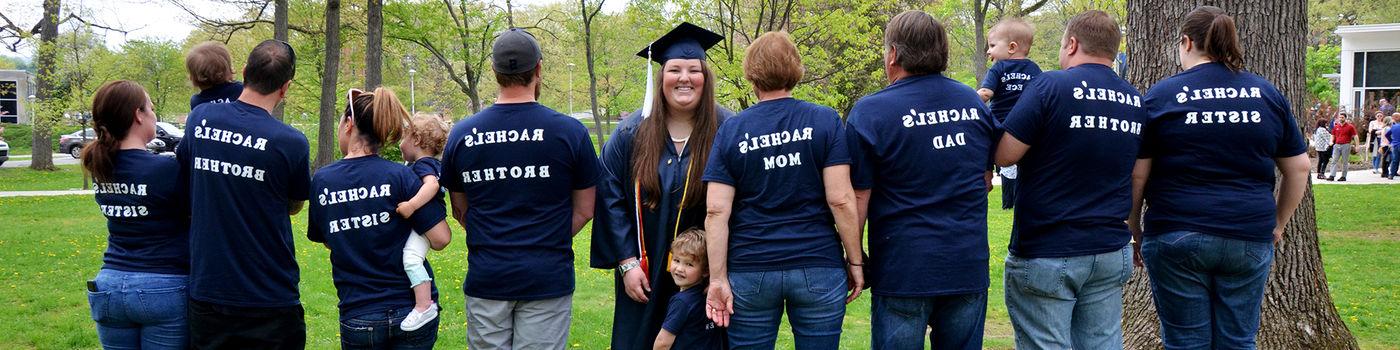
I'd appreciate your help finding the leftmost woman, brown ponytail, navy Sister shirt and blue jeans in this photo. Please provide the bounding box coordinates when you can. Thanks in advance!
[83,80,189,349]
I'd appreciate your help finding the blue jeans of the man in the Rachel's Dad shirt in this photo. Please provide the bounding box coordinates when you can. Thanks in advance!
[871,291,987,350]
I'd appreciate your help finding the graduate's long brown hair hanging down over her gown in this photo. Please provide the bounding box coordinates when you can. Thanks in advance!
[631,62,720,210]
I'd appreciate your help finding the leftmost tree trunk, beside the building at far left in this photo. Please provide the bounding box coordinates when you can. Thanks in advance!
[29,0,60,170]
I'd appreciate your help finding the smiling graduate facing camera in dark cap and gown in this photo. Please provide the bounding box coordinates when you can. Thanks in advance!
[589,22,734,350]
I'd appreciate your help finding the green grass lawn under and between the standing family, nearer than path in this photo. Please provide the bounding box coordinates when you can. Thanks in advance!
[0,184,1400,349]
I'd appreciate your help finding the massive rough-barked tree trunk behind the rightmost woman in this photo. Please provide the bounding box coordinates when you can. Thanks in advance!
[1123,0,1357,349]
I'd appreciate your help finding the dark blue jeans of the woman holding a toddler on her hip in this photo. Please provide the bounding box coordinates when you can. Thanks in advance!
[340,307,442,350]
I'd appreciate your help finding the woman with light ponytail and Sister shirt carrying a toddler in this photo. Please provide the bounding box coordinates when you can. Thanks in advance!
[307,87,452,349]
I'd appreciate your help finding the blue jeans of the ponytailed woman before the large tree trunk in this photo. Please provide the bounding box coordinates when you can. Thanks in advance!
[1142,231,1274,349]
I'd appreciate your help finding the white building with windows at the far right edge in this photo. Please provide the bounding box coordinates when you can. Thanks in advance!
[1337,24,1400,118]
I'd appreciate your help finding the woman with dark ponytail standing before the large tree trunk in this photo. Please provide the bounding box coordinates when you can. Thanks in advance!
[1128,6,1309,349]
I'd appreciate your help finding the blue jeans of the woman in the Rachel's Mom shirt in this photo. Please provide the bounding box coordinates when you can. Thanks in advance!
[728,267,846,350]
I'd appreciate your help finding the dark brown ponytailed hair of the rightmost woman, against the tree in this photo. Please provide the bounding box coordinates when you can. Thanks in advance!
[1182,6,1245,71]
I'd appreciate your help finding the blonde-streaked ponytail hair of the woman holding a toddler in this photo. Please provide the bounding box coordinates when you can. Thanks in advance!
[344,87,409,153]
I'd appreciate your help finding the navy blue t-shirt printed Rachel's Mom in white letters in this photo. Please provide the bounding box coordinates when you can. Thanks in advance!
[701,98,851,272]
